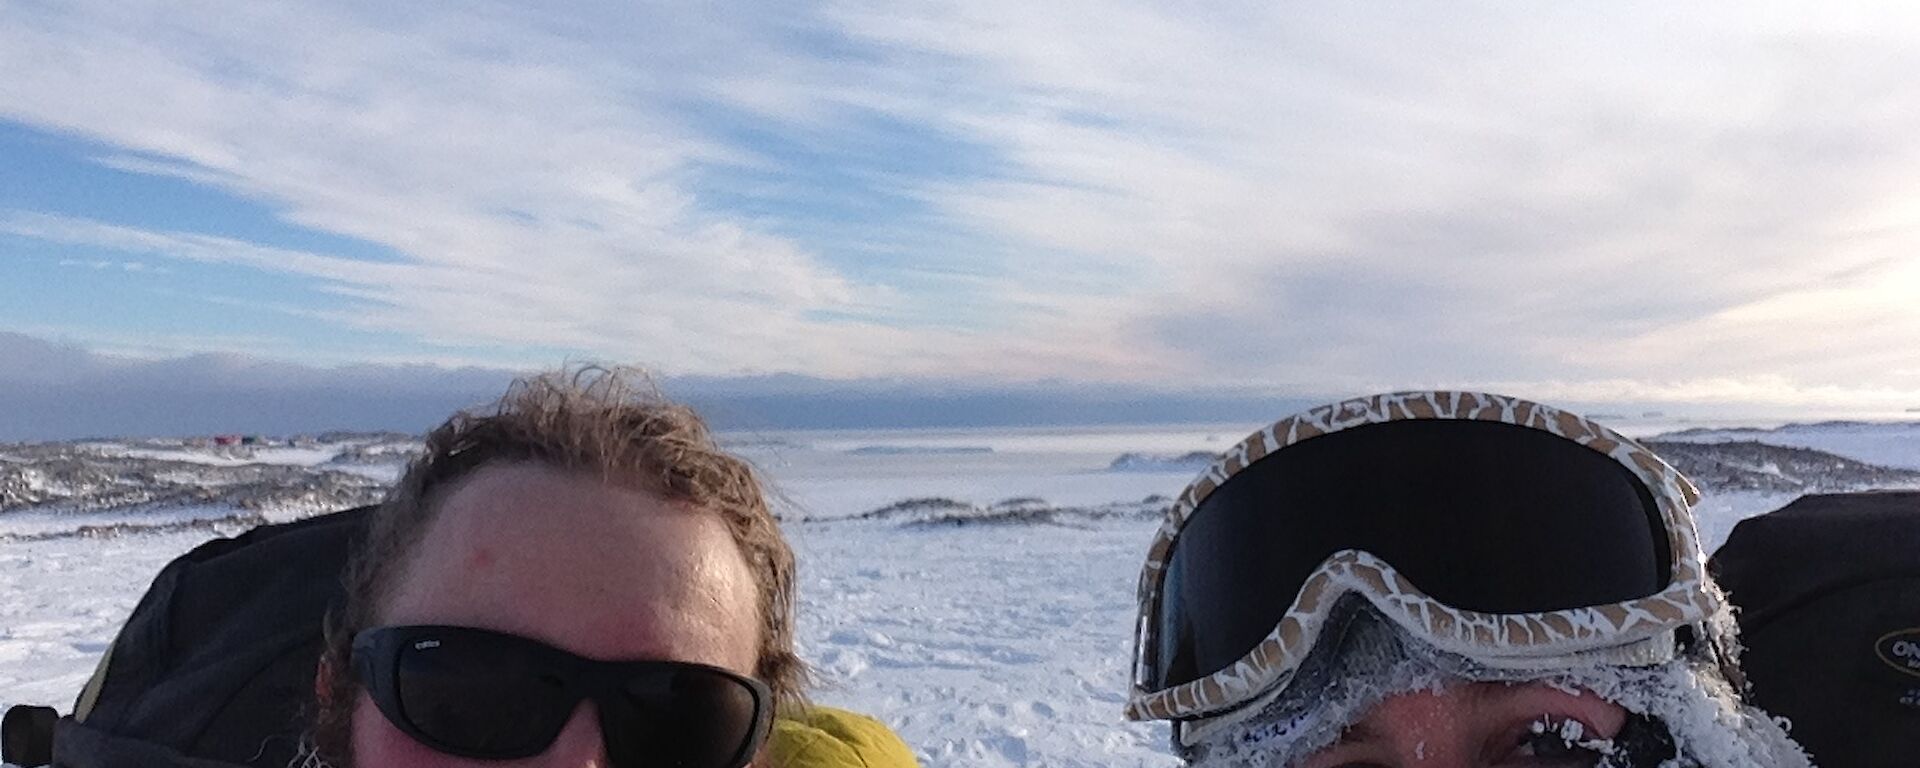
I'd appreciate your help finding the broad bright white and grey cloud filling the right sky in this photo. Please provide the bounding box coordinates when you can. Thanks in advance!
[806,2,1920,405]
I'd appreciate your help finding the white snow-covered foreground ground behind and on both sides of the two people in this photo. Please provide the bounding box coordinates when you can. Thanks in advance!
[0,493,1791,768]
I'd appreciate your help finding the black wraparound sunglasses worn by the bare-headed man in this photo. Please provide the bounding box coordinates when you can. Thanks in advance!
[353,626,774,768]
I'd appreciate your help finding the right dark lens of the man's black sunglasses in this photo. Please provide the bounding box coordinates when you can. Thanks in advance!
[597,664,770,768]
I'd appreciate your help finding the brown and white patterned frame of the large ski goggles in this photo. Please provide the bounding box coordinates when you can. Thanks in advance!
[1127,392,1720,720]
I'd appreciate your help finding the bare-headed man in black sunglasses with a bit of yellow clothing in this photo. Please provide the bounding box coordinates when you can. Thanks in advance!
[309,369,914,768]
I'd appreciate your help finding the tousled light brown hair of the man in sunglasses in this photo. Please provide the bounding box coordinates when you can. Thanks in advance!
[313,365,808,766]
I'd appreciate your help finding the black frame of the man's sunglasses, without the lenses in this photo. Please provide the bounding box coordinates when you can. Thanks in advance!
[351,624,774,768]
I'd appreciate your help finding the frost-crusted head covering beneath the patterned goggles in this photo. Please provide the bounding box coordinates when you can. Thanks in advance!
[1175,597,1809,768]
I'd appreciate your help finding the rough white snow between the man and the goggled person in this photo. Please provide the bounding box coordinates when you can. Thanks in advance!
[791,520,1179,768]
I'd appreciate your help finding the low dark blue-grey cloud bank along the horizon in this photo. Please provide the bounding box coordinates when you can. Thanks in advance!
[0,332,1306,442]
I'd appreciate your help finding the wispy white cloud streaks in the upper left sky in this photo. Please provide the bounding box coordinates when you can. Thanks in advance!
[0,4,929,371]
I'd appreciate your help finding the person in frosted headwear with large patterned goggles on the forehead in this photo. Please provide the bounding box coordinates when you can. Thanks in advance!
[1127,392,1807,768]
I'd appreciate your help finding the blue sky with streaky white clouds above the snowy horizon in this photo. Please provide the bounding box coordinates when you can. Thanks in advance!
[0,0,1920,440]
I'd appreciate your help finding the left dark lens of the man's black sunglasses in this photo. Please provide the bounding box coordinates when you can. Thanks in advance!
[396,632,578,758]
